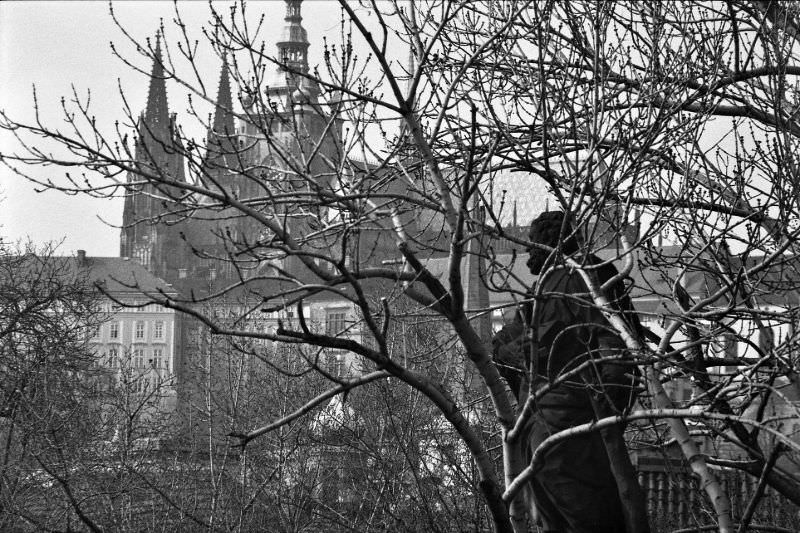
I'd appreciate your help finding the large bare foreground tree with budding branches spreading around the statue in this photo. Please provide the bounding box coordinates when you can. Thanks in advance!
[2,0,800,531]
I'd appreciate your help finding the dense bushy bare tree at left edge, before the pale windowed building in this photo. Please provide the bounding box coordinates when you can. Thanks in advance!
[0,241,108,529]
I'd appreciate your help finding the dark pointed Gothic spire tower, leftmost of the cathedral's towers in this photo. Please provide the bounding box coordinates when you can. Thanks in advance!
[120,36,186,279]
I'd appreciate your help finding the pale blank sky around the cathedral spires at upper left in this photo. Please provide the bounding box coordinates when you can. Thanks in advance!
[0,0,348,256]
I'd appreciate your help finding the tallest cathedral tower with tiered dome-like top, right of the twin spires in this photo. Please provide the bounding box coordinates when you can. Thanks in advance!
[231,0,343,268]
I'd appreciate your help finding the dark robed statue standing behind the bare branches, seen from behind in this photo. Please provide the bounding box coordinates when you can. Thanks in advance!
[492,211,641,533]
